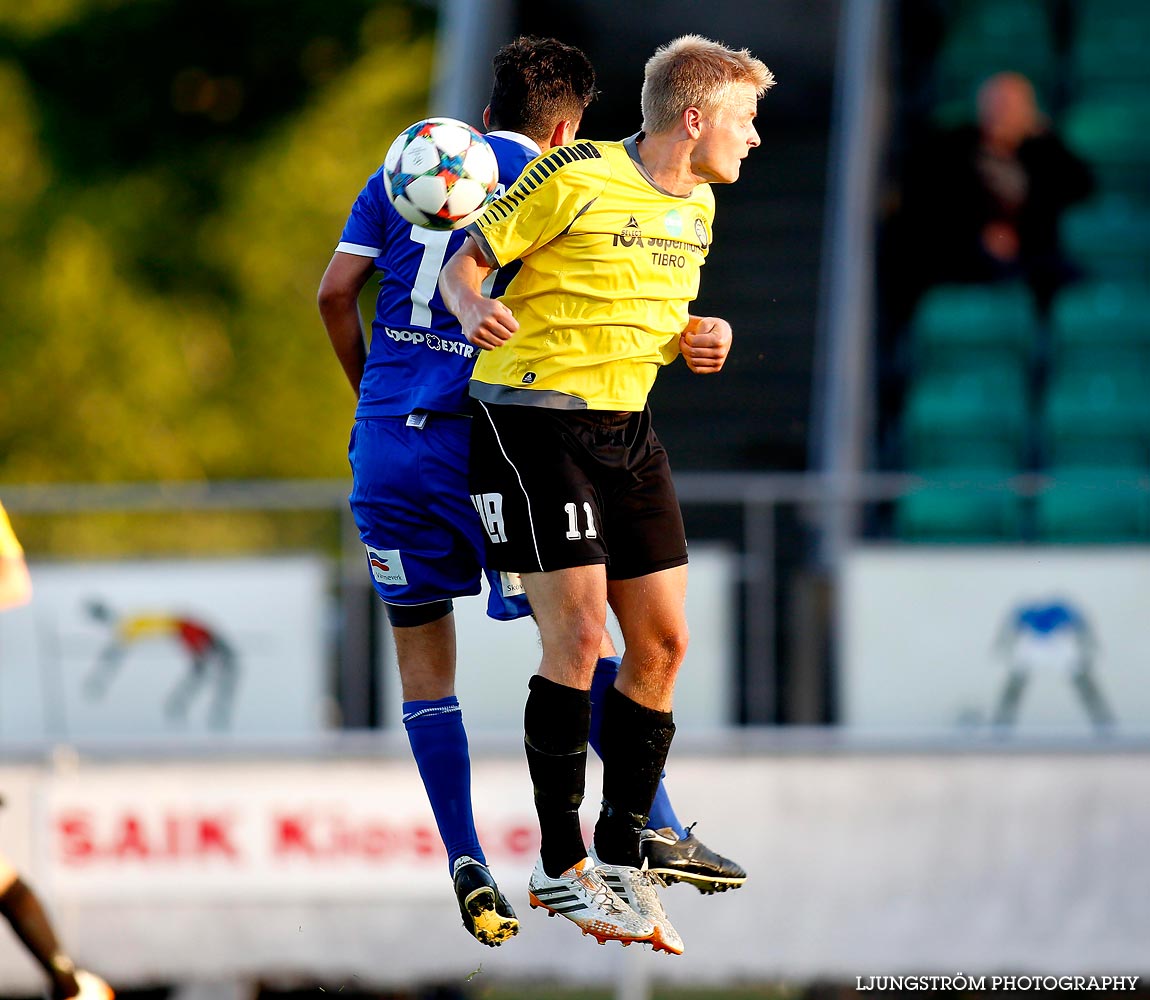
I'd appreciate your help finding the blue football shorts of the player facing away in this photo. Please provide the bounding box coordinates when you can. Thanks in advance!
[347,414,531,621]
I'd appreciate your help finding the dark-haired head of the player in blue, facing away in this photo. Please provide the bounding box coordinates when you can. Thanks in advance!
[490,34,596,141]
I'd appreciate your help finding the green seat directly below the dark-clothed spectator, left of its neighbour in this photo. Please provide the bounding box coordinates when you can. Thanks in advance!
[911,283,1038,370]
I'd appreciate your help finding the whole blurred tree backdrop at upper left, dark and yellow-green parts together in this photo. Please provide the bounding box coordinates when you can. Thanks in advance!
[0,0,435,483]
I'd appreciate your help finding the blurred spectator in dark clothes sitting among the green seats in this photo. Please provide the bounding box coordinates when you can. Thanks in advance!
[886,72,1094,324]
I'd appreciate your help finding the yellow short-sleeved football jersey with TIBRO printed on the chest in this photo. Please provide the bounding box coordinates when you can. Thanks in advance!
[468,136,714,410]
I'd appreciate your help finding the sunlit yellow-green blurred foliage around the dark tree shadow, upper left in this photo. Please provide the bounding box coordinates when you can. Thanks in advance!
[0,8,432,491]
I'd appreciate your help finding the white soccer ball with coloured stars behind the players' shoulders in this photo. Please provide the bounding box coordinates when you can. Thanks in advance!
[383,118,499,230]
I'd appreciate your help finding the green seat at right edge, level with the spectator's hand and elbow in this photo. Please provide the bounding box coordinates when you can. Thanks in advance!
[1063,193,1150,282]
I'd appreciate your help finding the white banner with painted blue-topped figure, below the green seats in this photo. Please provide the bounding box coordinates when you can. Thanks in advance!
[840,547,1150,737]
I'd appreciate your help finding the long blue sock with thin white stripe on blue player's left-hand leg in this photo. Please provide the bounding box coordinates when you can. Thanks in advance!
[404,695,488,870]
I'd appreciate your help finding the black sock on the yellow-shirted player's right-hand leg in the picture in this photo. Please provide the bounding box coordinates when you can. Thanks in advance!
[595,687,675,868]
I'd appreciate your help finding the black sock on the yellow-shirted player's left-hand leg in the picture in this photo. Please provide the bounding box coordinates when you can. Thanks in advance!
[523,675,591,878]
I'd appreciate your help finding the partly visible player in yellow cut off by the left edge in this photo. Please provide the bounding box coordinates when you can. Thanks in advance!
[0,505,114,1000]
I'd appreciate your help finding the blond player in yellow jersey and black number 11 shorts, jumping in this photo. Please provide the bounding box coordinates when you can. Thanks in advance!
[439,36,774,954]
